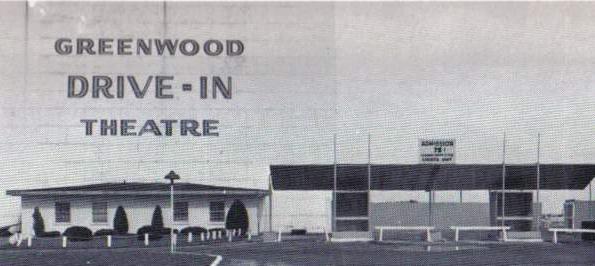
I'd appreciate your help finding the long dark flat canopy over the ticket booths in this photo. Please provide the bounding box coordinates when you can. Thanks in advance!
[270,164,595,190]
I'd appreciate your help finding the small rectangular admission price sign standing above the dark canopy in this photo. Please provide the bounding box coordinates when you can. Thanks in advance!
[419,139,455,164]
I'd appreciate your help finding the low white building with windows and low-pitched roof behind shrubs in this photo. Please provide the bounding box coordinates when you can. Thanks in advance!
[7,182,268,235]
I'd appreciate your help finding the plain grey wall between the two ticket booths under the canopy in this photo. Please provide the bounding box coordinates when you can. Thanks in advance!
[370,202,490,229]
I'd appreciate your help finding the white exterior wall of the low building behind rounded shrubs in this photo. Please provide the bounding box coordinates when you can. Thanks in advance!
[22,193,261,235]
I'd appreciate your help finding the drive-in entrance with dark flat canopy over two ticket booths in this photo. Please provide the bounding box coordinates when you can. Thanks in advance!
[270,164,595,240]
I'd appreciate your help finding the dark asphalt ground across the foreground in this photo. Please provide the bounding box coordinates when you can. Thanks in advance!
[0,240,595,266]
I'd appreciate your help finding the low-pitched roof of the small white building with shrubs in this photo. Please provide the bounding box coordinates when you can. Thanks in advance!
[6,182,268,196]
